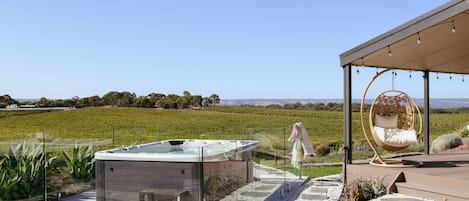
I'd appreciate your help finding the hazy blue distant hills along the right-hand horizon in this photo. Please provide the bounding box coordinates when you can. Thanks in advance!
[220,98,469,108]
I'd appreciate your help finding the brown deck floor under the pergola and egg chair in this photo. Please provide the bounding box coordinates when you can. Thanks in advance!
[347,150,469,201]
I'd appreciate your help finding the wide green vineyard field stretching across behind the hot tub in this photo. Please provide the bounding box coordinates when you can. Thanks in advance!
[0,106,469,147]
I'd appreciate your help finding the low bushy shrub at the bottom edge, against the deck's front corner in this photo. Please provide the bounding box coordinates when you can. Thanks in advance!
[346,179,386,201]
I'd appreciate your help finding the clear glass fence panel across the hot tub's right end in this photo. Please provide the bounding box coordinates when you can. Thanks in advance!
[197,128,297,200]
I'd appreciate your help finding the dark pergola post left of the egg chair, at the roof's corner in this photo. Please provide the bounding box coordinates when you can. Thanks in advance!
[343,64,352,164]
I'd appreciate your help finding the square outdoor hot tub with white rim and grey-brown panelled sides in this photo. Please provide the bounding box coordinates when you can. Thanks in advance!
[95,140,259,201]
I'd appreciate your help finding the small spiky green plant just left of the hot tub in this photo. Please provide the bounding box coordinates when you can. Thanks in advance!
[62,145,95,181]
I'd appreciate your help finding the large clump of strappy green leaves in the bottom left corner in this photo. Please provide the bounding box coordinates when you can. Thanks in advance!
[0,143,54,200]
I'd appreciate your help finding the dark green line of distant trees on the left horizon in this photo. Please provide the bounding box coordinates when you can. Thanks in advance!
[0,91,220,109]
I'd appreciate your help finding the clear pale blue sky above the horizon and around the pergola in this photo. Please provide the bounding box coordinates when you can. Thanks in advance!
[0,0,462,99]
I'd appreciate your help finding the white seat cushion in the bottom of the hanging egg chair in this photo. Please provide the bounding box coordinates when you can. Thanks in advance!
[374,126,417,147]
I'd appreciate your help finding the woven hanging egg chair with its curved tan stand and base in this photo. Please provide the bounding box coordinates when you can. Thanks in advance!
[360,69,423,168]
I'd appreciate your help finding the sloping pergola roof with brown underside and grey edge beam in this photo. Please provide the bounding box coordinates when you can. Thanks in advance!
[340,0,469,74]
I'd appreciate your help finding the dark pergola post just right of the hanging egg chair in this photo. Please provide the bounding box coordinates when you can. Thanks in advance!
[423,70,430,155]
